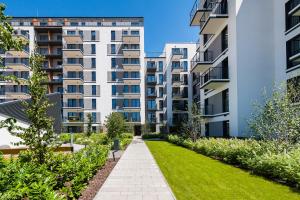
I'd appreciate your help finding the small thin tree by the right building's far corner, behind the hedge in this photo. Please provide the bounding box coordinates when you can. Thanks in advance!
[182,103,204,142]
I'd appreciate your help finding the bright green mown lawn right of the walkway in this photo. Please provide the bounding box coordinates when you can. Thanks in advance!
[146,141,300,200]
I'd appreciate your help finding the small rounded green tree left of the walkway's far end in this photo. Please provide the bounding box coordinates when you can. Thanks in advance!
[105,112,126,139]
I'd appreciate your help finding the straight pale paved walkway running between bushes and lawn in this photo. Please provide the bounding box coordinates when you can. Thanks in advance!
[94,137,175,200]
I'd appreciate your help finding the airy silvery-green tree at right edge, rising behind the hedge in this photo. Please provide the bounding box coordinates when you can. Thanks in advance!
[248,84,300,152]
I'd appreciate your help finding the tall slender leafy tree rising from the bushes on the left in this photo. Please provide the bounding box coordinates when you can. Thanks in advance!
[1,52,57,164]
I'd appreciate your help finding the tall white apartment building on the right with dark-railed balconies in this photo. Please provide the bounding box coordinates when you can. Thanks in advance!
[190,0,300,137]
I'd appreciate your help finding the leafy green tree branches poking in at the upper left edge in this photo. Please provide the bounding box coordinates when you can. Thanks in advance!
[0,4,27,82]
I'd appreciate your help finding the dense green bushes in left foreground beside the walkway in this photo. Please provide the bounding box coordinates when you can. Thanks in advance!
[0,144,109,200]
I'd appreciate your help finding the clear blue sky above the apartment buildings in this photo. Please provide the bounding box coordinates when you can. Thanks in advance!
[2,0,199,52]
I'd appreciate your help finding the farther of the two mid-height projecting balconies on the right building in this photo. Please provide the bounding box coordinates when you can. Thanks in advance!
[191,51,214,73]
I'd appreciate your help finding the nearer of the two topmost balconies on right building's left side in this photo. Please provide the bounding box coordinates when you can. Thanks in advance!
[200,0,228,35]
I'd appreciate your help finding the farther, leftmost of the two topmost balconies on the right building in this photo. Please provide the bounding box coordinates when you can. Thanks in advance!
[190,0,216,26]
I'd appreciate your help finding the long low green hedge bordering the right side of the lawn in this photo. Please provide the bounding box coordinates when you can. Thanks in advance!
[167,135,300,188]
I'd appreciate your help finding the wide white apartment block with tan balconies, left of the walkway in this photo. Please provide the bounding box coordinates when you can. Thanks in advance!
[0,17,145,132]
